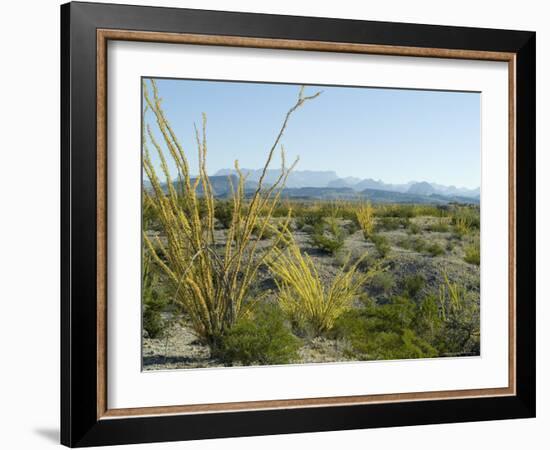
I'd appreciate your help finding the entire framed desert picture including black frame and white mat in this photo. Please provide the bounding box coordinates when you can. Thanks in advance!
[61,3,535,447]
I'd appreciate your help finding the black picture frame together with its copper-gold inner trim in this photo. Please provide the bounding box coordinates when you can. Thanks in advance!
[61,2,535,446]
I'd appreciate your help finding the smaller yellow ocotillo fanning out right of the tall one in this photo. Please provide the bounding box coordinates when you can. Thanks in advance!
[268,234,376,334]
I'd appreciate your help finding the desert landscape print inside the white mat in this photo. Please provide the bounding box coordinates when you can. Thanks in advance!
[140,77,481,371]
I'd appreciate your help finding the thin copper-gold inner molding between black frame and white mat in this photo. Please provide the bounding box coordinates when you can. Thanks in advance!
[97,29,516,419]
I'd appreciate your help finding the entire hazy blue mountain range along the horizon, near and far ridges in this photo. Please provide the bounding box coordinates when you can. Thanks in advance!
[149,169,479,204]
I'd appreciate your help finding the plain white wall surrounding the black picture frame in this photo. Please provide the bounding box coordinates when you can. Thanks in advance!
[0,0,550,450]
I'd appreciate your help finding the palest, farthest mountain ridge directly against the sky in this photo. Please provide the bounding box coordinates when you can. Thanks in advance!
[214,169,479,200]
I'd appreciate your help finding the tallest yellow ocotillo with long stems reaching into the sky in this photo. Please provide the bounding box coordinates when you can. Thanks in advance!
[142,80,319,349]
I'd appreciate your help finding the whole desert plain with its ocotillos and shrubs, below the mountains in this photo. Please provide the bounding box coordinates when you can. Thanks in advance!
[142,81,480,369]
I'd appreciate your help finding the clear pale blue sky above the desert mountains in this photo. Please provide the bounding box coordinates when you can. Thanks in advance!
[143,79,481,188]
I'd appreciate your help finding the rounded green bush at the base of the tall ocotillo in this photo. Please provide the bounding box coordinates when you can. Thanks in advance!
[215,305,300,365]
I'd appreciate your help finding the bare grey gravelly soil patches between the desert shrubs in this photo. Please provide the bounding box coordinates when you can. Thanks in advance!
[142,217,480,370]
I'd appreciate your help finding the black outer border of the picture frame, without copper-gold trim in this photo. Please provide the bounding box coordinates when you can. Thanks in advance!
[61,3,535,447]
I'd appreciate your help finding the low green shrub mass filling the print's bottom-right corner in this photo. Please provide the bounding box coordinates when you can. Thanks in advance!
[331,272,479,359]
